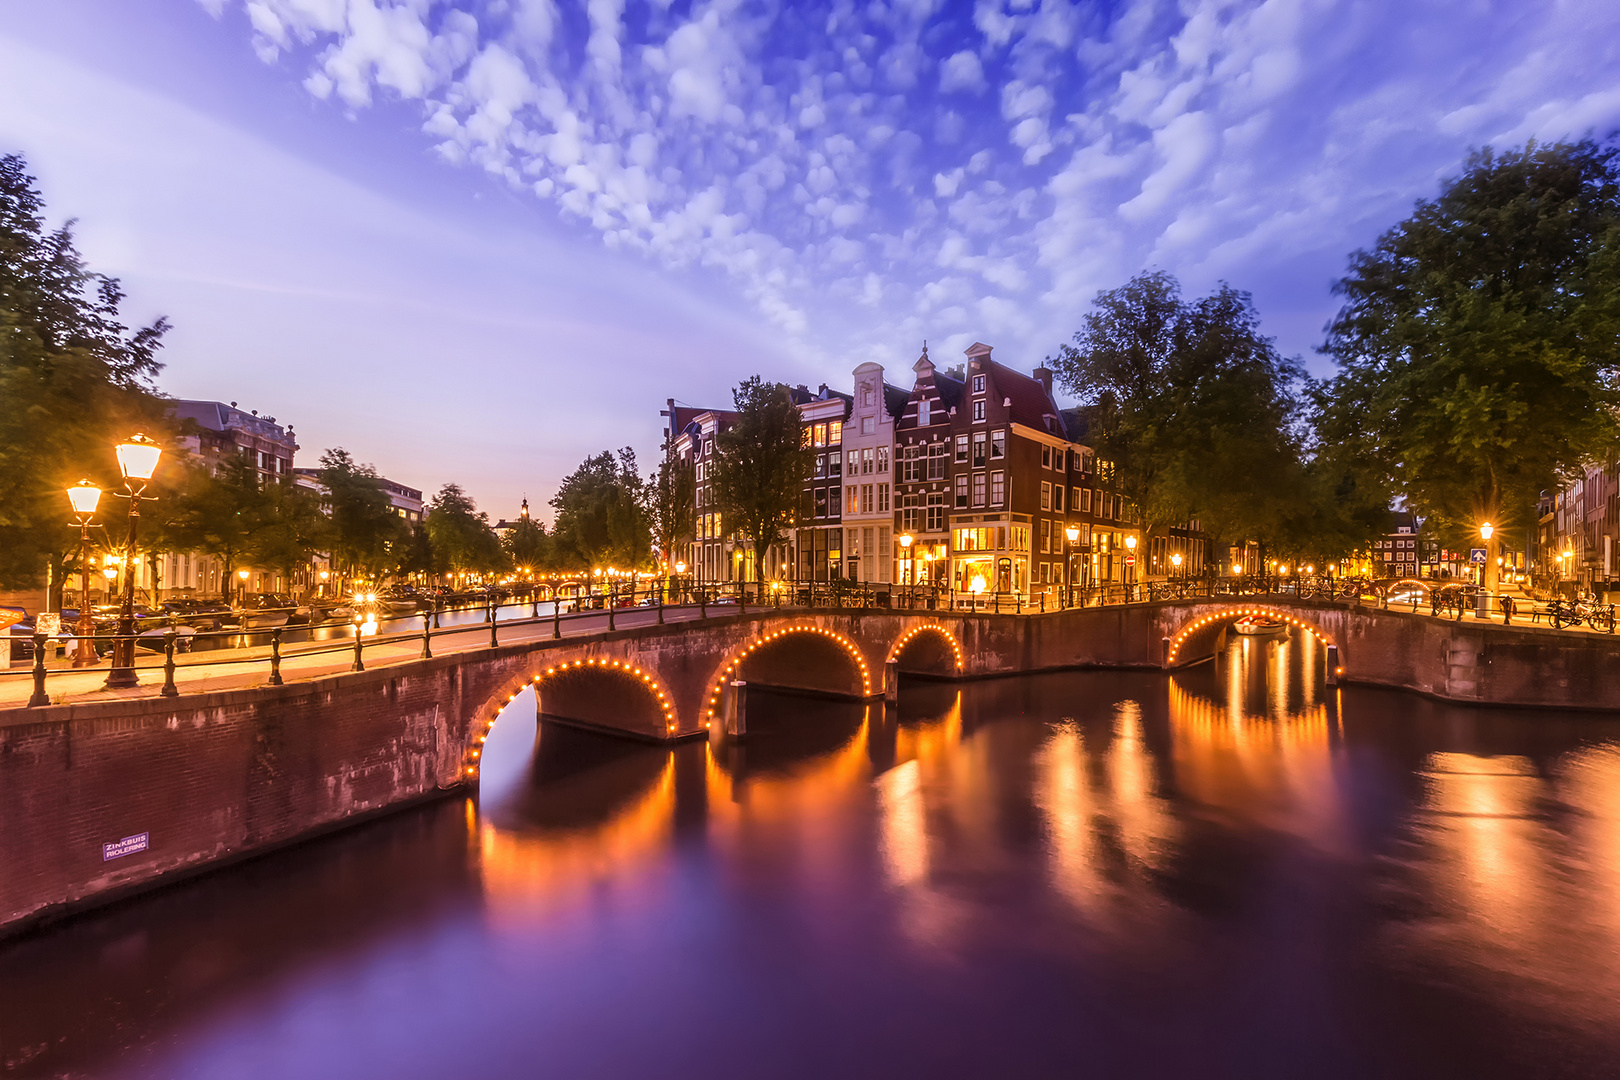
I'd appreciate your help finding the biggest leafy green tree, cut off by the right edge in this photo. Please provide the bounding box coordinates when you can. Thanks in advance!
[1319,141,1620,575]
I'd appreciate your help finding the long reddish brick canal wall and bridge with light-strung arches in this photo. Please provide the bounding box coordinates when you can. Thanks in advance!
[9,602,1620,934]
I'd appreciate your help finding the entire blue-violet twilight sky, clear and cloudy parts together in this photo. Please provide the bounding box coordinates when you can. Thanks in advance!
[0,0,1620,515]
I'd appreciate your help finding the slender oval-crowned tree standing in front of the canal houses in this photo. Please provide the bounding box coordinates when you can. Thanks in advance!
[714,376,815,581]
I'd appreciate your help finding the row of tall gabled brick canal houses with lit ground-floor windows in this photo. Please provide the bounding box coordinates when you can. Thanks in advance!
[664,343,1207,601]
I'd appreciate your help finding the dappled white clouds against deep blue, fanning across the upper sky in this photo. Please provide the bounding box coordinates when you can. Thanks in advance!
[199,0,1620,366]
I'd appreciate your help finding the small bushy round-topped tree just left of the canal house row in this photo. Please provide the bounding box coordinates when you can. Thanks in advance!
[551,447,650,570]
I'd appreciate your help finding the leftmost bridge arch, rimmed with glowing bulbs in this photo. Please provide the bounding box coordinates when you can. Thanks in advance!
[462,656,680,780]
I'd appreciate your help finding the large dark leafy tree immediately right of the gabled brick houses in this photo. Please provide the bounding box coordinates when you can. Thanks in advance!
[1051,270,1306,566]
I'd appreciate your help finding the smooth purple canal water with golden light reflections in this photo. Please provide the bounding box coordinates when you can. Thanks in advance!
[0,635,1620,1080]
